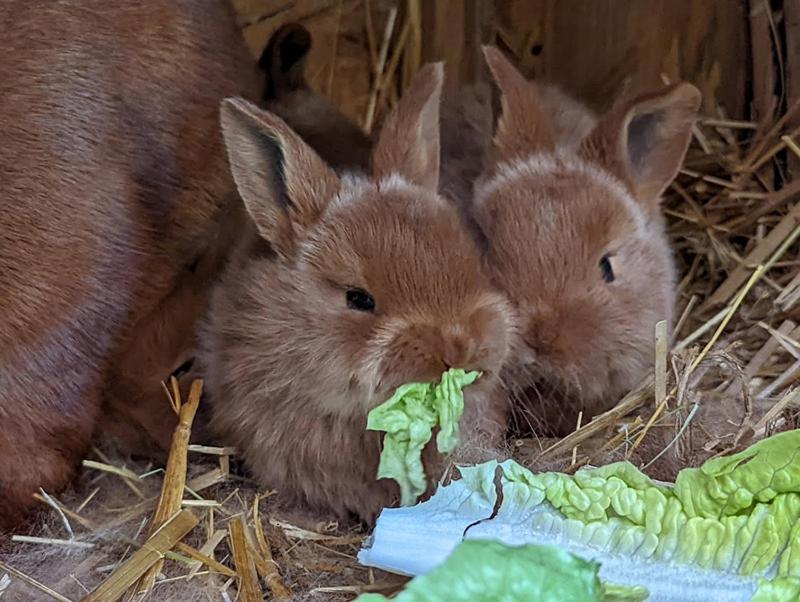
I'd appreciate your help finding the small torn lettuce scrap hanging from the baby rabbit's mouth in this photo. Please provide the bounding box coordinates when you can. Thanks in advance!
[367,368,480,506]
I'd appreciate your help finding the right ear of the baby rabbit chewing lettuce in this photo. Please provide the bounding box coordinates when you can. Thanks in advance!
[372,63,444,191]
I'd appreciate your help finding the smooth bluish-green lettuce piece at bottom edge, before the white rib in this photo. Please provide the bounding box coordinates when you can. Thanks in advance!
[356,540,646,602]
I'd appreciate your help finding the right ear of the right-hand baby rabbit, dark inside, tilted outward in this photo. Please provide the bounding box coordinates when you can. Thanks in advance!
[579,83,701,205]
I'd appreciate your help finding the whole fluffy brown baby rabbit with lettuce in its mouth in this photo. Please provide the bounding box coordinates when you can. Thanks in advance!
[200,64,512,521]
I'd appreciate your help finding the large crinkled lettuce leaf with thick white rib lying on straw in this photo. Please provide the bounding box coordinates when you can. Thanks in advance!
[359,430,800,602]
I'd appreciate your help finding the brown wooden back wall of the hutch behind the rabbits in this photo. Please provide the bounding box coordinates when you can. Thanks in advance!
[232,0,800,123]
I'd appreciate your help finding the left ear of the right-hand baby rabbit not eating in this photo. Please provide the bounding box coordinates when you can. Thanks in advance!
[483,46,555,160]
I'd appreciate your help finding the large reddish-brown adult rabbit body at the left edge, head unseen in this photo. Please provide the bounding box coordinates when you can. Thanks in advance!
[0,0,260,529]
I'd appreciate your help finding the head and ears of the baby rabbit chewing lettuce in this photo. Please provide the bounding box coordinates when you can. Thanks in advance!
[216,65,508,411]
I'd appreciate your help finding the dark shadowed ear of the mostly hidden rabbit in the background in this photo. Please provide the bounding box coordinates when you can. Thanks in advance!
[258,23,311,100]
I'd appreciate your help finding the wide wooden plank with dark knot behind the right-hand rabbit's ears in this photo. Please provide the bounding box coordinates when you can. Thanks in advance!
[496,0,749,119]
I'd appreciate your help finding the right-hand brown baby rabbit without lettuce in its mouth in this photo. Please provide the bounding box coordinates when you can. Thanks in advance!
[472,47,700,435]
